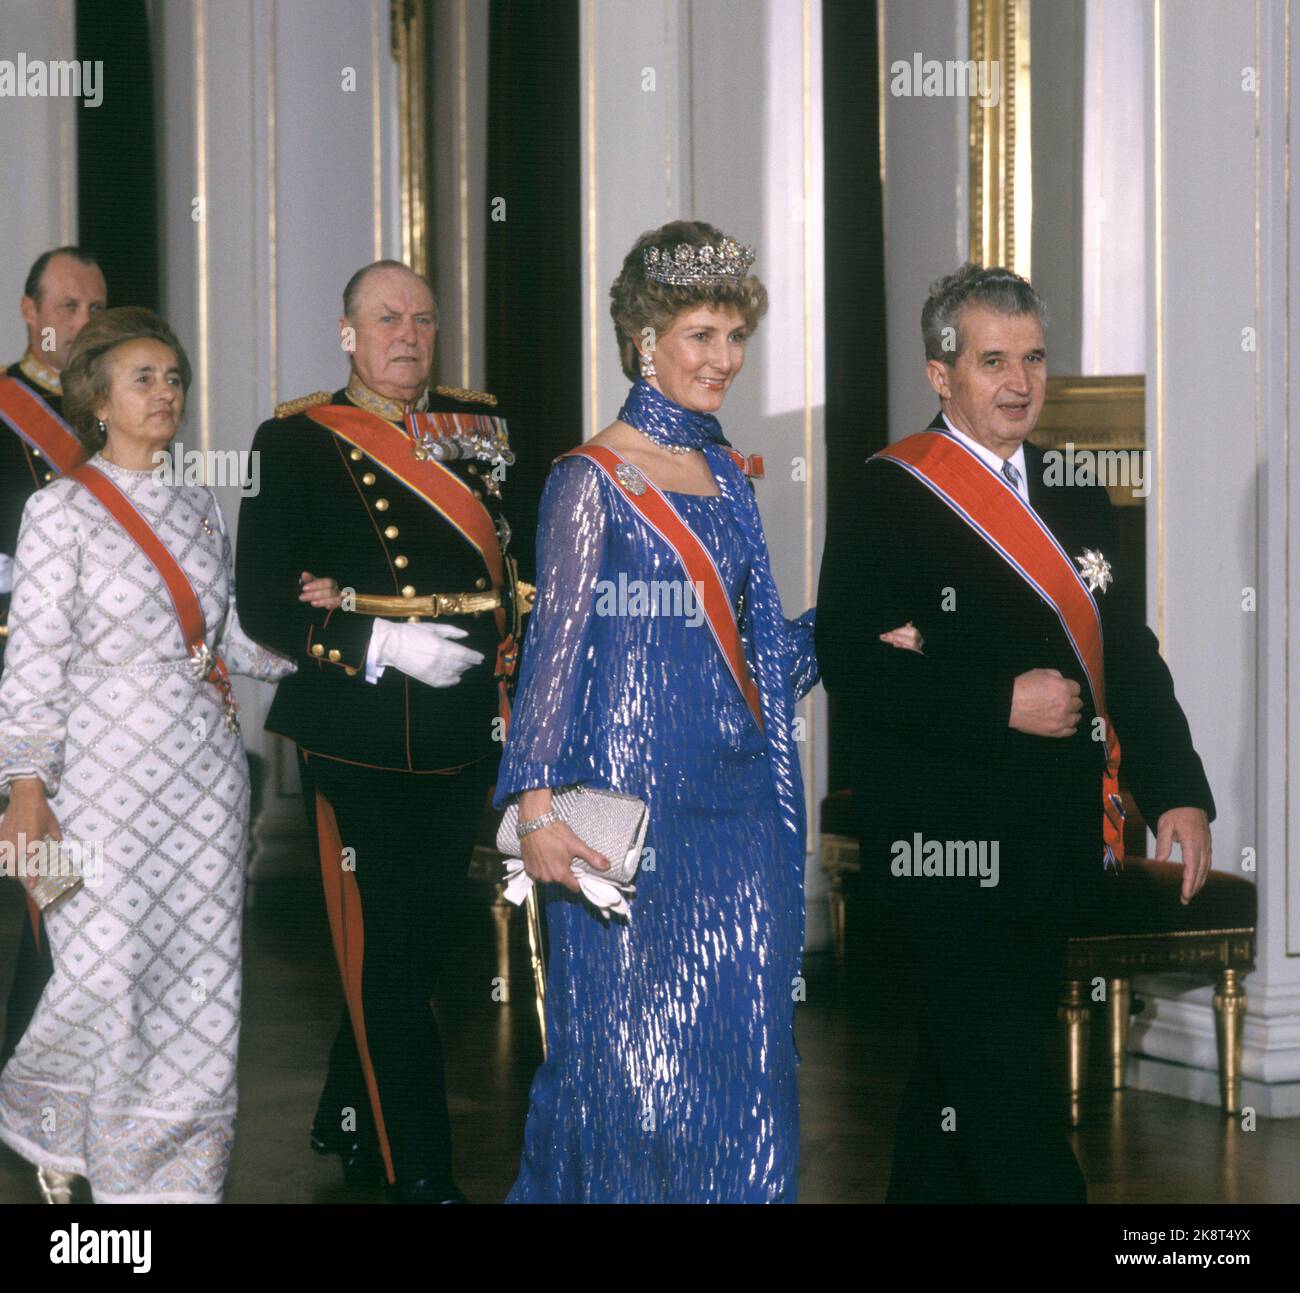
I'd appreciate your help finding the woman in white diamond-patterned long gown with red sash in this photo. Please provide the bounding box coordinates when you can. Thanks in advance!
[0,308,314,1202]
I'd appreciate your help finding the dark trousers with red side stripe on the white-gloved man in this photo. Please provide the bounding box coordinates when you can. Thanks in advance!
[299,755,497,1193]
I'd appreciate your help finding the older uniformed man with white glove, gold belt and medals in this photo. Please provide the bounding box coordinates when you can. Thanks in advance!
[237,261,520,1202]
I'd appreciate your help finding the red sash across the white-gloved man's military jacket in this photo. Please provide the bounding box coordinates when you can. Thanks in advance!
[304,404,519,726]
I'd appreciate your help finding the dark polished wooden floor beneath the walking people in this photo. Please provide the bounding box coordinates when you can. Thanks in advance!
[0,872,1300,1203]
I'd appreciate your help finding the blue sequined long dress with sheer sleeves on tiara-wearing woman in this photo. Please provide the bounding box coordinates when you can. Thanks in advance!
[497,383,816,1202]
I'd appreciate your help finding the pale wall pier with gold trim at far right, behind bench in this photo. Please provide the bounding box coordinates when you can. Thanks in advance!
[1131,0,1300,1116]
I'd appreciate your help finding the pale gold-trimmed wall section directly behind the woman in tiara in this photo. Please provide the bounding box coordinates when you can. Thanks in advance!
[581,0,828,949]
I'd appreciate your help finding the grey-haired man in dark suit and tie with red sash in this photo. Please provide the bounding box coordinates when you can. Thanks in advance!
[816,265,1214,1202]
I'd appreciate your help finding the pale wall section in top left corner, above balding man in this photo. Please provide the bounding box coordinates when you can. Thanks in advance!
[0,0,78,365]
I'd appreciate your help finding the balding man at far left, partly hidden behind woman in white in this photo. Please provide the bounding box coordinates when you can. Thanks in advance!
[0,247,108,1067]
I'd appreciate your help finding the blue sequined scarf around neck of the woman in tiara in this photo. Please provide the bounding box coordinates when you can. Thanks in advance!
[619,381,807,893]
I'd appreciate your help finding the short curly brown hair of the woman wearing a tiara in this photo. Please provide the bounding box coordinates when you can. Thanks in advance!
[610,220,767,382]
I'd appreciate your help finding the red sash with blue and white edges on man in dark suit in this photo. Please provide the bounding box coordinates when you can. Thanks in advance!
[875,431,1125,865]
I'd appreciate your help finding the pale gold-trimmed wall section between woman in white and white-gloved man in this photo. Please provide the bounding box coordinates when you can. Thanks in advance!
[152,0,399,878]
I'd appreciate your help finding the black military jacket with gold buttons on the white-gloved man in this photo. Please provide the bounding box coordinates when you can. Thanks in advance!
[235,389,514,773]
